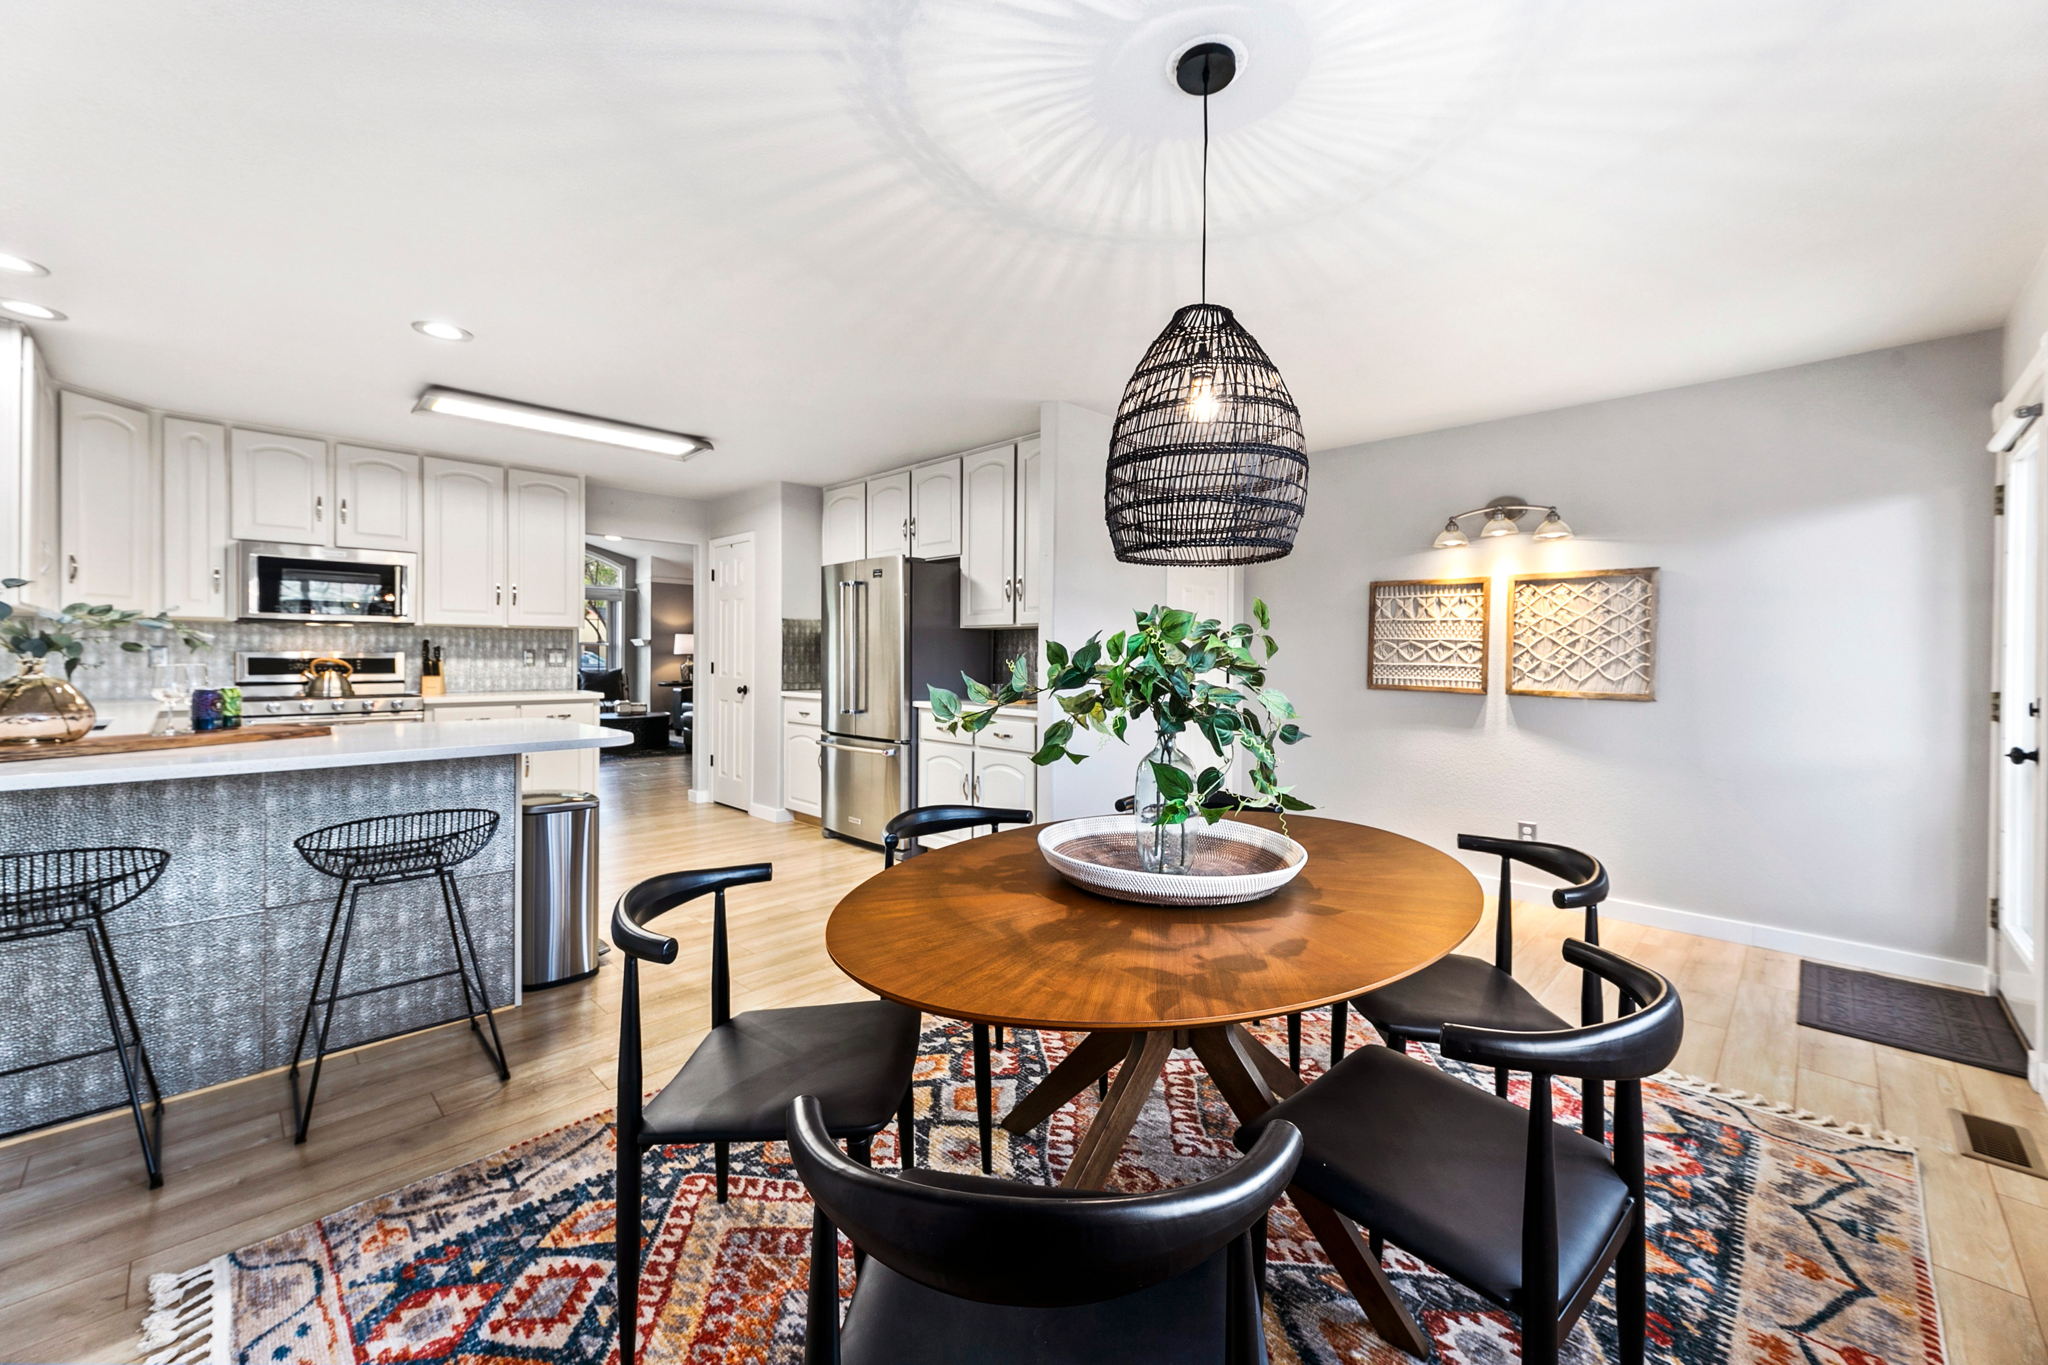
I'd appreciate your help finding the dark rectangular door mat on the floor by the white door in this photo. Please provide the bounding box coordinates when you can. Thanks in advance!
[1798,962,2028,1076]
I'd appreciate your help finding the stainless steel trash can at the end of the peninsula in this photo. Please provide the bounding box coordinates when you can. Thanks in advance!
[518,792,598,990]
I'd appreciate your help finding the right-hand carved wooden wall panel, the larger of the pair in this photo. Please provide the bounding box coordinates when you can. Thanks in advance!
[1507,569,1657,702]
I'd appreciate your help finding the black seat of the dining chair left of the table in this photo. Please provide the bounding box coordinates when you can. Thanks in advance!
[643,1001,920,1142]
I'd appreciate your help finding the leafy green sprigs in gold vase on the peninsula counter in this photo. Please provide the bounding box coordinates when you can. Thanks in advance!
[0,579,209,745]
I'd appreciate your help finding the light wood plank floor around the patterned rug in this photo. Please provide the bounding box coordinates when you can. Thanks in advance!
[0,759,2048,1365]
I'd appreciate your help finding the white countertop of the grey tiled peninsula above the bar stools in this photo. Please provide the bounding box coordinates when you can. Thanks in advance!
[0,720,633,792]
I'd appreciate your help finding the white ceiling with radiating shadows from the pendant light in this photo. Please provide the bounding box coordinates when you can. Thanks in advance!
[0,0,2048,495]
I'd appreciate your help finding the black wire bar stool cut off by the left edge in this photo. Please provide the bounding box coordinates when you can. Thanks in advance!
[0,847,170,1189]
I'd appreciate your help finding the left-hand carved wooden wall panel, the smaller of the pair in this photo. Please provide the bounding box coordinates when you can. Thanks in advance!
[1366,577,1493,696]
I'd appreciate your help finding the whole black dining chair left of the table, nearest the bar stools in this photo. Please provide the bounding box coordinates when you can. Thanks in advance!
[612,864,920,1365]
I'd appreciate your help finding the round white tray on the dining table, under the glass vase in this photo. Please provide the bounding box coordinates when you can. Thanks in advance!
[1038,814,1309,905]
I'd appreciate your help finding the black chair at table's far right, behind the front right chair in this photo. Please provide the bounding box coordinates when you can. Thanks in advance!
[1329,835,1608,1138]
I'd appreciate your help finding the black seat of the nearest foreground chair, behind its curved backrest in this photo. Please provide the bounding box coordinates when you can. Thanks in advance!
[840,1171,1229,1365]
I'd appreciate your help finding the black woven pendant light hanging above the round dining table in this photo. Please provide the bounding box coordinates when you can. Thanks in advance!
[1104,43,1309,565]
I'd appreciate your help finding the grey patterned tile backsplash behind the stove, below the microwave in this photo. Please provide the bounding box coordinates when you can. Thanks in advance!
[49,620,575,702]
